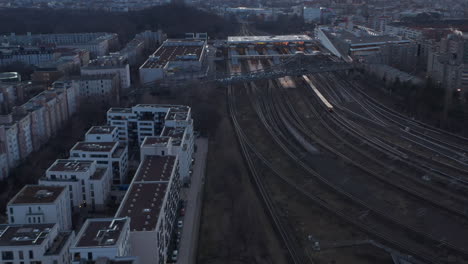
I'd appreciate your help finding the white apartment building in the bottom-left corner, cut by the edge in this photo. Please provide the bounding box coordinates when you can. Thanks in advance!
[0,223,74,264]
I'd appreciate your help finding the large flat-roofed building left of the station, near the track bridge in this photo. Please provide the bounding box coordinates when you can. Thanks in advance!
[139,39,206,84]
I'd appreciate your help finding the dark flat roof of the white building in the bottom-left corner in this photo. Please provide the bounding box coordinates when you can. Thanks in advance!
[0,224,55,247]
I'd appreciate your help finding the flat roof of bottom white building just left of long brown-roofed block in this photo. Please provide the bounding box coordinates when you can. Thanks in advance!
[74,218,130,247]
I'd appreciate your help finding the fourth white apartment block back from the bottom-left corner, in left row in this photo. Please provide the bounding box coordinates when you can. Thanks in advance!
[70,142,128,184]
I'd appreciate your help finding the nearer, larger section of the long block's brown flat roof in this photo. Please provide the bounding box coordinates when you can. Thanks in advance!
[118,182,168,231]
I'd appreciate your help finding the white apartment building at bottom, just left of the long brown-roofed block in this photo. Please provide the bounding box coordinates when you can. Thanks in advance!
[70,217,134,264]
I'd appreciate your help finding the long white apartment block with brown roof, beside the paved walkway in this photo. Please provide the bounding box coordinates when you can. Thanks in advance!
[116,156,181,264]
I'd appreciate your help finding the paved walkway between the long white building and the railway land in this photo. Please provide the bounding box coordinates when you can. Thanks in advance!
[177,138,208,264]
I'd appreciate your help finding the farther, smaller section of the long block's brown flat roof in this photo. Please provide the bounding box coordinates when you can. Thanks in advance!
[135,156,176,182]
